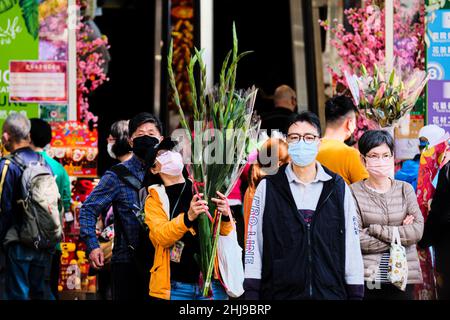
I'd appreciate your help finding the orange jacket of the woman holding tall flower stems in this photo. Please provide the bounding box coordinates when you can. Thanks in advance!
[145,185,233,300]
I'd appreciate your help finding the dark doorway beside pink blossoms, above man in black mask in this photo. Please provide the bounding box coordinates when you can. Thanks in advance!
[89,1,155,175]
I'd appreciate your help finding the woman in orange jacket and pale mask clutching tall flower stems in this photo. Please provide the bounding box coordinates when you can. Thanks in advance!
[145,139,232,300]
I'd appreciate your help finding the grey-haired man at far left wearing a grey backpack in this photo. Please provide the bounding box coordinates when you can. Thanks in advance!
[0,113,52,300]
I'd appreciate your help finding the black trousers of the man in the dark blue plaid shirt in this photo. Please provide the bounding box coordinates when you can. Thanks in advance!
[111,263,150,301]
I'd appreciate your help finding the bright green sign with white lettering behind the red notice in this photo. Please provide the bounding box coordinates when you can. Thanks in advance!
[0,0,39,130]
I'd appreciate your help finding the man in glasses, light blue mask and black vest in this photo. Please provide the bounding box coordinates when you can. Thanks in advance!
[244,112,364,300]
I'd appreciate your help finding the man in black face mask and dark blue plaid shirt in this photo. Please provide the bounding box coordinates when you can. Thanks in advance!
[80,112,162,300]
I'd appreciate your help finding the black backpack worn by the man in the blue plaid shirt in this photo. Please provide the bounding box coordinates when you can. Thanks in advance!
[110,164,155,277]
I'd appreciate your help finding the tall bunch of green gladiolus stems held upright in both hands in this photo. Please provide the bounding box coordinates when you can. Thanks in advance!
[168,25,260,296]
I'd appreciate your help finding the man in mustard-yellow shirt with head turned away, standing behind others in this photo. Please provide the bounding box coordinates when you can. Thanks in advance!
[317,96,368,185]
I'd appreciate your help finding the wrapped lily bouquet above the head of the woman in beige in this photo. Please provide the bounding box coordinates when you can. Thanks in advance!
[345,65,428,128]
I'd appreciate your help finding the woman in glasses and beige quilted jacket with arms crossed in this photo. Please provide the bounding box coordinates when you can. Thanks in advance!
[351,130,424,300]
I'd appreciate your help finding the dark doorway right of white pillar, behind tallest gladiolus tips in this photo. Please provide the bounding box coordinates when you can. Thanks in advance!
[214,0,295,113]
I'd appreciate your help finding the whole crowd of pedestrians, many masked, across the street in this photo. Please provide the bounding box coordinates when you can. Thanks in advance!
[0,85,450,300]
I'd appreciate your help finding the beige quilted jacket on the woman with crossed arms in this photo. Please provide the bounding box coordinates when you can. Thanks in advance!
[351,180,424,284]
